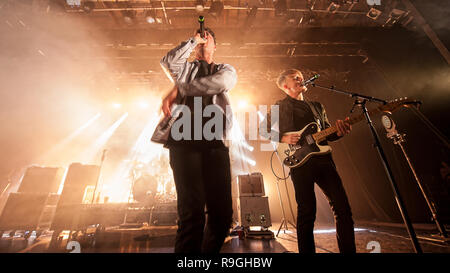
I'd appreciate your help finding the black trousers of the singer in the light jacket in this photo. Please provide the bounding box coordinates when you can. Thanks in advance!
[169,145,233,253]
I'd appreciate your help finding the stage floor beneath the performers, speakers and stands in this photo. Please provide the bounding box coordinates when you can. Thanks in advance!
[0,222,450,253]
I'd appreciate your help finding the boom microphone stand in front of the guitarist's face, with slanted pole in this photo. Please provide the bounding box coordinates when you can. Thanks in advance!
[311,82,422,253]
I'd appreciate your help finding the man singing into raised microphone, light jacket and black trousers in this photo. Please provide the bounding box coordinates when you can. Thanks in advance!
[156,26,237,253]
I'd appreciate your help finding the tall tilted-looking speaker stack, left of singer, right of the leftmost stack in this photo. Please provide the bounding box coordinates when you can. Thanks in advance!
[51,163,100,230]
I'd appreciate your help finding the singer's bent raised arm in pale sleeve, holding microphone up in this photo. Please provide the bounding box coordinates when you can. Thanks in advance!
[160,37,197,82]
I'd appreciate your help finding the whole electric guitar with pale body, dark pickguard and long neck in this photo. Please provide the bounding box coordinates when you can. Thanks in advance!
[277,98,420,168]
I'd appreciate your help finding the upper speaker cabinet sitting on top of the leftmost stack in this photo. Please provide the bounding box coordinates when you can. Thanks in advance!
[17,166,64,193]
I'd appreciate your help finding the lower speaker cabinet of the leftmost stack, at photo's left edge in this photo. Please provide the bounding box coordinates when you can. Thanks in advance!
[0,193,49,230]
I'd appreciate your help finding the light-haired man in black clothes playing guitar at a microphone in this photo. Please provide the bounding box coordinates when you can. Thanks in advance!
[260,69,356,253]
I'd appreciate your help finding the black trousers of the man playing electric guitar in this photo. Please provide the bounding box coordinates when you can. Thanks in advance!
[291,155,356,253]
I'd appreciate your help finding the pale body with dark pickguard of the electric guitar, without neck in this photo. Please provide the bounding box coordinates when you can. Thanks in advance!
[277,122,331,168]
